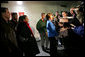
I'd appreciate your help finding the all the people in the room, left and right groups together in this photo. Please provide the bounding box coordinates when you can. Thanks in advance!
[0,2,84,56]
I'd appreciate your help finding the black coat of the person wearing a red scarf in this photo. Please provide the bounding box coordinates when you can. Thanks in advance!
[17,22,39,56]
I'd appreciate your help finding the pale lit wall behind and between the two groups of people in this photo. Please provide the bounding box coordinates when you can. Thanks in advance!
[1,1,69,38]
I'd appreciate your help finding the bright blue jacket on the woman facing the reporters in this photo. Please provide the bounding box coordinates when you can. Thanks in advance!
[46,20,58,37]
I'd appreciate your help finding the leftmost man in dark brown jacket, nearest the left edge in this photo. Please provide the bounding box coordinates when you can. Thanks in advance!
[0,7,23,56]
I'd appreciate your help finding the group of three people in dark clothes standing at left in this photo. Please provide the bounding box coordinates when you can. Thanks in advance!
[0,7,40,56]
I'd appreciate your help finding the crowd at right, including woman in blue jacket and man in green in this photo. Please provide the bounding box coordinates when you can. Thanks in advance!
[36,4,84,56]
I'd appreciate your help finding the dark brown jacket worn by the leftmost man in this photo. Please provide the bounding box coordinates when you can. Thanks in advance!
[0,18,22,56]
